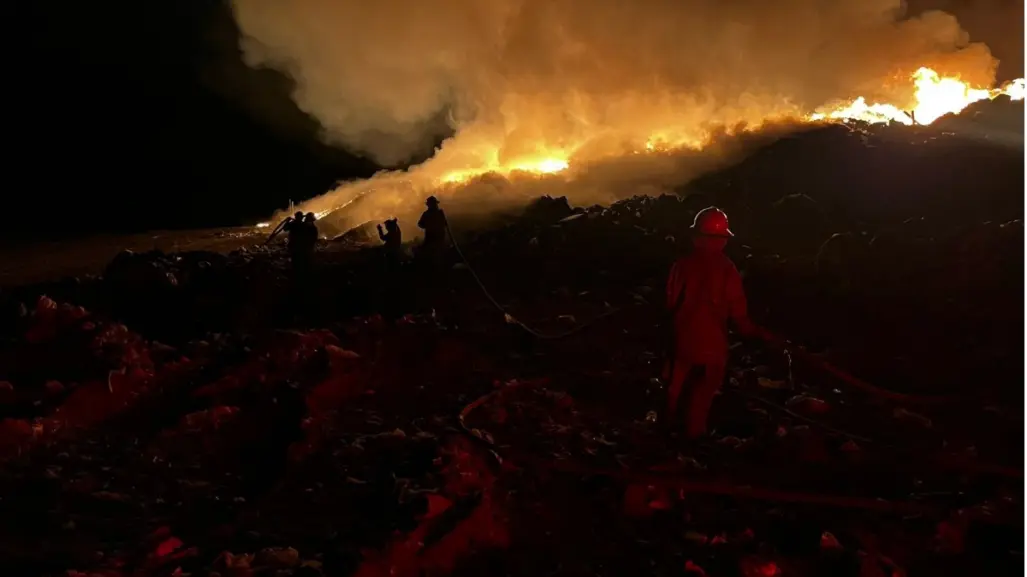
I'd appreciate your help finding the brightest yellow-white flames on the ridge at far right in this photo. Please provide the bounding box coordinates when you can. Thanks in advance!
[809,68,1024,125]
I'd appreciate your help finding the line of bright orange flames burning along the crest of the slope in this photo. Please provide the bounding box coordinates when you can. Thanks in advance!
[259,68,1024,243]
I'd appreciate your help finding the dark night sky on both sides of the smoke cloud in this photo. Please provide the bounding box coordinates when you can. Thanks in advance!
[2,0,1023,242]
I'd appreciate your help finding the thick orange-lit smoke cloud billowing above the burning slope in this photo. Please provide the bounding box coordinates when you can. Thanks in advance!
[233,0,997,234]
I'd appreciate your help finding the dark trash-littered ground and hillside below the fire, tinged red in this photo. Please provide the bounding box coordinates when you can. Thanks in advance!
[0,122,1024,576]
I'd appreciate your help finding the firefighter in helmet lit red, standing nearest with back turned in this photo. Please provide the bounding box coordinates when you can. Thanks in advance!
[664,206,763,438]
